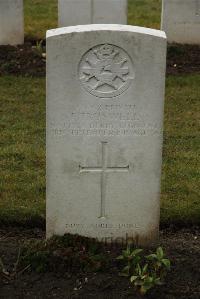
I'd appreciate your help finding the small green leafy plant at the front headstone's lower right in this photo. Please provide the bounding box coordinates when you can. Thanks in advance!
[117,245,170,295]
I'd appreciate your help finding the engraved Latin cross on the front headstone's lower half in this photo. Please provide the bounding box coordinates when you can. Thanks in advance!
[79,141,129,218]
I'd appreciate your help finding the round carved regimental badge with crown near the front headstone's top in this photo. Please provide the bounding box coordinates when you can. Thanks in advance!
[79,44,135,98]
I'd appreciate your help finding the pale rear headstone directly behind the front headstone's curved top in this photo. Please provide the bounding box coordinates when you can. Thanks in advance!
[58,0,127,27]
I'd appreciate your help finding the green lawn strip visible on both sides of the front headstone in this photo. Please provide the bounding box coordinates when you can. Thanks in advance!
[0,75,200,223]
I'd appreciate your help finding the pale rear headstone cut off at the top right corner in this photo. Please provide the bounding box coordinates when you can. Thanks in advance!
[161,0,200,44]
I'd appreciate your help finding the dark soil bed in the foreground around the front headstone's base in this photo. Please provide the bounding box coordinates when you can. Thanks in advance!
[0,227,200,299]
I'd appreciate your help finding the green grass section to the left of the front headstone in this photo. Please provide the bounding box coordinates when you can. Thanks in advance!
[0,76,45,226]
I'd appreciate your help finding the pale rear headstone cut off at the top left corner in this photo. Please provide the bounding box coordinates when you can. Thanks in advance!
[0,0,24,45]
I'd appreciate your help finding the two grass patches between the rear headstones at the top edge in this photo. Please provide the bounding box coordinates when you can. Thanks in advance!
[24,0,161,39]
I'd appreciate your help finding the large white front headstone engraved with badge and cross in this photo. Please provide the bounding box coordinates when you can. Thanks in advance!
[47,25,166,244]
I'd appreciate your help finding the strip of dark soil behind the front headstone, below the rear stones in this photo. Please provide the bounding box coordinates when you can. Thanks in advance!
[0,41,200,76]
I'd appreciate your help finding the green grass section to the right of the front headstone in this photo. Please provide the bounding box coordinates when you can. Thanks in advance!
[161,75,200,223]
